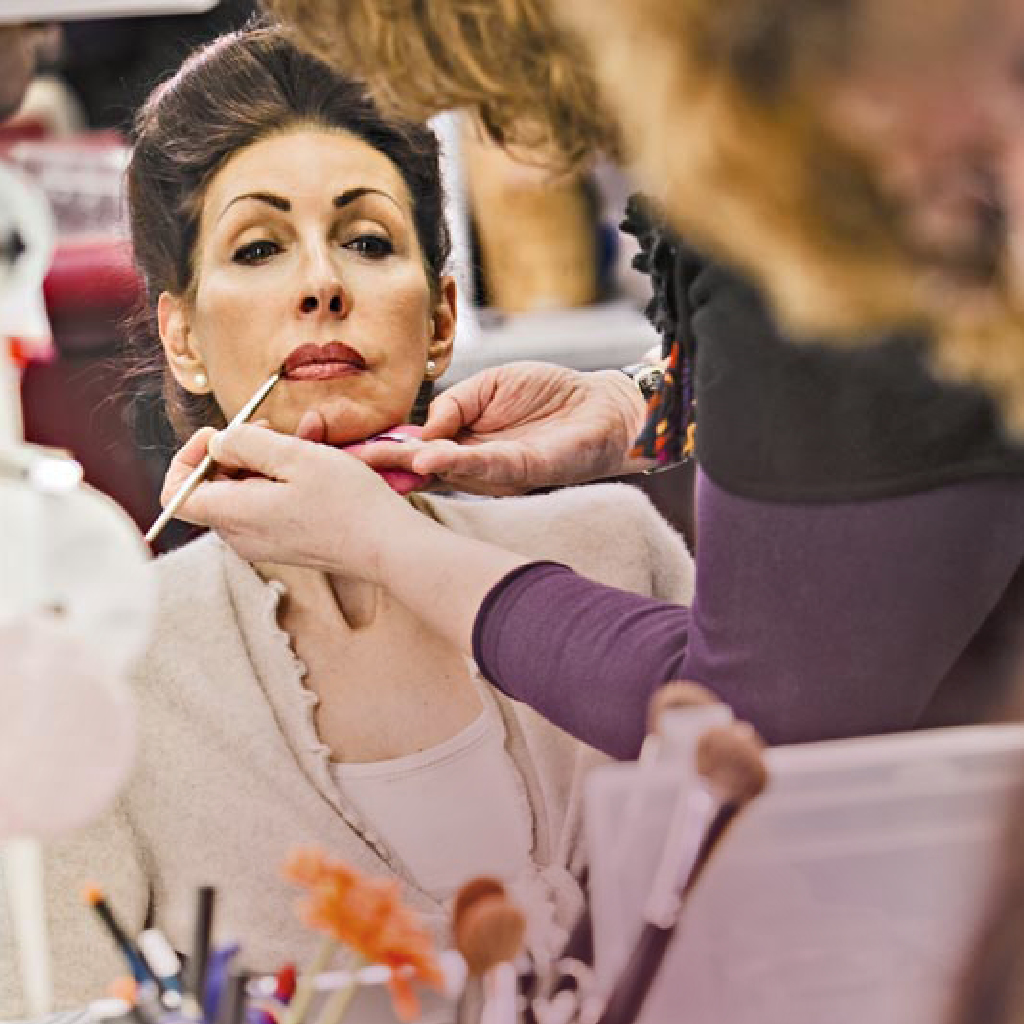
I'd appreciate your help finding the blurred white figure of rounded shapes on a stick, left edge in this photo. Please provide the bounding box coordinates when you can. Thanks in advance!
[0,157,155,1017]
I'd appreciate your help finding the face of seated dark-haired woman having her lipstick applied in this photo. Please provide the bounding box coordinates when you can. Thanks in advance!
[159,127,455,444]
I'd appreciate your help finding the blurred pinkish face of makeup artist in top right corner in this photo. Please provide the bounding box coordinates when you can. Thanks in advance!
[825,0,1024,292]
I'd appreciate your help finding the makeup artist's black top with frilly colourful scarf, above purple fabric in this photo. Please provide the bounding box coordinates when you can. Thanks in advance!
[624,200,1024,503]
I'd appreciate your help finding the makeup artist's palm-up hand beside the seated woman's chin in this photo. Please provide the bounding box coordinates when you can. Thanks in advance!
[348,361,645,495]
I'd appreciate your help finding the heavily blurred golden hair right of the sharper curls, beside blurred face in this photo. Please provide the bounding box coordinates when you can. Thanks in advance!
[552,0,1024,435]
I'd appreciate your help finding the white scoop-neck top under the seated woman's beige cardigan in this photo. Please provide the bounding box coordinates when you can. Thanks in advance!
[331,684,534,900]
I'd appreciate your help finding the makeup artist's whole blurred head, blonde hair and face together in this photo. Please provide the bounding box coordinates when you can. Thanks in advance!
[263,0,1024,430]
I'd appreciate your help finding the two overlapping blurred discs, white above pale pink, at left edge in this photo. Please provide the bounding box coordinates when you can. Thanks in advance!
[0,477,153,840]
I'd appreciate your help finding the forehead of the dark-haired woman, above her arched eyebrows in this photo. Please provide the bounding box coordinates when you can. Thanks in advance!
[203,128,412,219]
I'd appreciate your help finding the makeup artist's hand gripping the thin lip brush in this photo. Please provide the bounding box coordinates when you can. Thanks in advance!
[161,425,419,583]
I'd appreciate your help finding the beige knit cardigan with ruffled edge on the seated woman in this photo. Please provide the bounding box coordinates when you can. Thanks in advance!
[0,484,693,1020]
